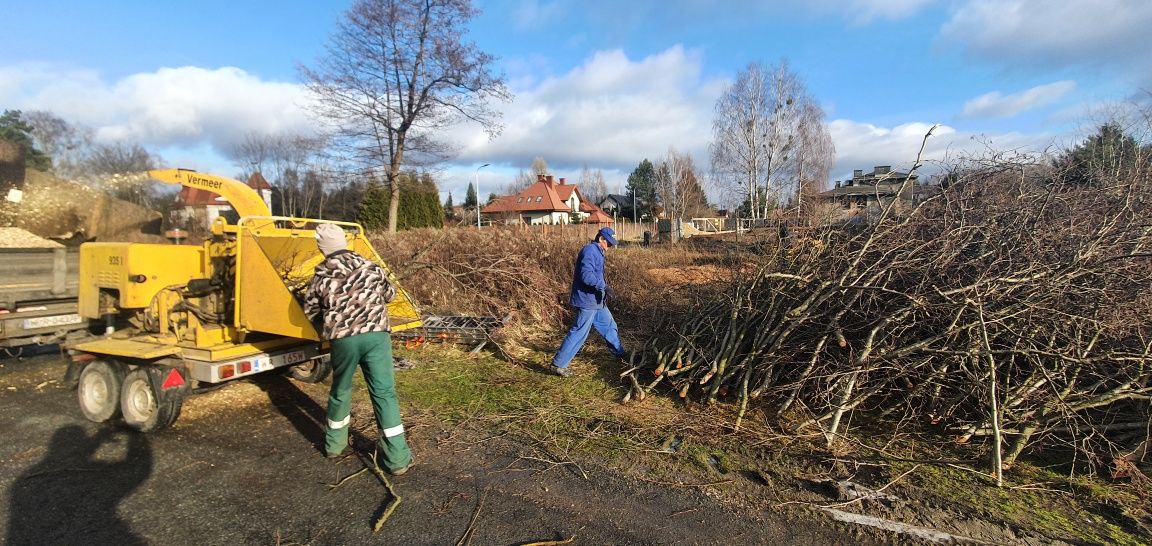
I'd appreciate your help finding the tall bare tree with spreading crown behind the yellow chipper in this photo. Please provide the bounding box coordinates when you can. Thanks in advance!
[301,0,510,233]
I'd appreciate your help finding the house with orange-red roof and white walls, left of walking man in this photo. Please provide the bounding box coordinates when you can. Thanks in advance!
[480,175,612,226]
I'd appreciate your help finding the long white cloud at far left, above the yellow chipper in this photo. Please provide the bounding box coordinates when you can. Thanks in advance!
[0,65,312,153]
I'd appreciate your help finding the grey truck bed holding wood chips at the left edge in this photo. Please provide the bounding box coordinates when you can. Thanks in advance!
[0,227,88,356]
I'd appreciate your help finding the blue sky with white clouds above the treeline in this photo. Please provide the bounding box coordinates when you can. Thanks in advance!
[0,0,1152,202]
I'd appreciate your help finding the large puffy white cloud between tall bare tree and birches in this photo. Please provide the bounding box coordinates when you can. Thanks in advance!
[456,46,723,175]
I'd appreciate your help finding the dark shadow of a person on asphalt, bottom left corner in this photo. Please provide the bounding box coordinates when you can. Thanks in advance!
[5,425,152,546]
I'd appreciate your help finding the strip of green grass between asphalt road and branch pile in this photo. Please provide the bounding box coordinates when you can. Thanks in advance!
[345,346,1147,545]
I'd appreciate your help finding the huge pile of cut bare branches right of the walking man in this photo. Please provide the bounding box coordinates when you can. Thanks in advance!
[627,152,1152,471]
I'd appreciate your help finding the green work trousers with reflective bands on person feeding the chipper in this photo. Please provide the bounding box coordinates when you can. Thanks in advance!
[324,332,412,471]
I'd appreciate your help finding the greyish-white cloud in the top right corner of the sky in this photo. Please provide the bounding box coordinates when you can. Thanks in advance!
[940,0,1152,82]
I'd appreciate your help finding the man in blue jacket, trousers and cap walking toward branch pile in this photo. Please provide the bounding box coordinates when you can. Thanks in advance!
[550,227,624,378]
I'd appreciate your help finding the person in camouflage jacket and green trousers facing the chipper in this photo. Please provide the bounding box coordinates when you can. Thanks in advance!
[304,223,412,476]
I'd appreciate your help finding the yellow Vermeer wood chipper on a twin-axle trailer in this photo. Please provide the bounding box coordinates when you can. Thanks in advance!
[67,169,422,432]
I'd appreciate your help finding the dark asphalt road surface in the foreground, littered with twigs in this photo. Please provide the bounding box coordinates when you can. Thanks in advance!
[0,355,880,546]
